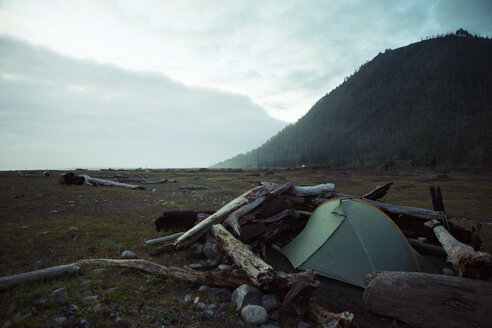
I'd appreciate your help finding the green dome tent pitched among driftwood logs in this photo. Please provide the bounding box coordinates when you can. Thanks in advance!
[281,198,435,287]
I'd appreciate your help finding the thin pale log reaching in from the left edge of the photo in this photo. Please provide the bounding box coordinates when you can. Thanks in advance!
[0,263,82,290]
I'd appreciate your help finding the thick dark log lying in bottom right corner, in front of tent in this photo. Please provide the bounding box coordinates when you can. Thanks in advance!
[363,272,492,328]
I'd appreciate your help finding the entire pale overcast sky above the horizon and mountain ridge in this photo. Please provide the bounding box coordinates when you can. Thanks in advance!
[0,0,492,169]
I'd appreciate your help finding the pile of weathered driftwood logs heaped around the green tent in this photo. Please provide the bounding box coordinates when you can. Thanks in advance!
[147,183,492,327]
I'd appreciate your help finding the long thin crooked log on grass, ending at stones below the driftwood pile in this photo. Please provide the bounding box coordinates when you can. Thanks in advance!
[80,259,249,287]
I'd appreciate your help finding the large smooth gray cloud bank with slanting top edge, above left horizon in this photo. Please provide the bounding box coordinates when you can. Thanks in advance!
[0,37,285,169]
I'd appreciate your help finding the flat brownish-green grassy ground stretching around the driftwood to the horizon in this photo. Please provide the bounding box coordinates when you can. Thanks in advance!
[0,168,492,327]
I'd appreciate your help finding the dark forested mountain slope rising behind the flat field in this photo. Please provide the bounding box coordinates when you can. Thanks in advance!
[215,29,492,168]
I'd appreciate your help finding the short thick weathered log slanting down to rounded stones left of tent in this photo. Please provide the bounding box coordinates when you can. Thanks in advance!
[210,224,277,289]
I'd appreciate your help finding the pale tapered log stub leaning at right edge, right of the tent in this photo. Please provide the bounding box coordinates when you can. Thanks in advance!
[426,220,492,280]
